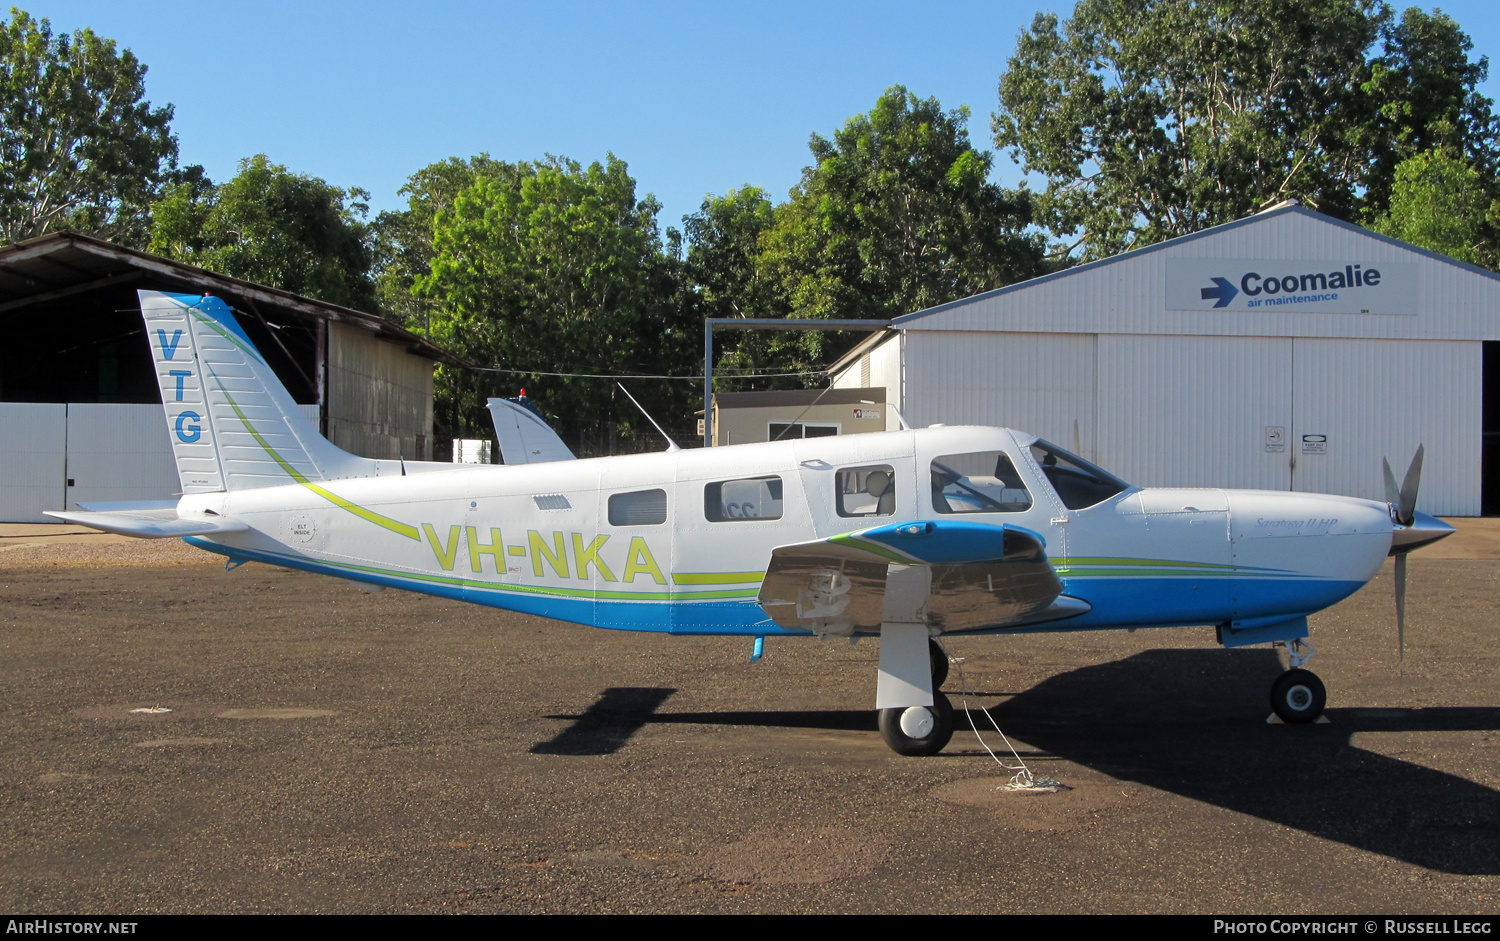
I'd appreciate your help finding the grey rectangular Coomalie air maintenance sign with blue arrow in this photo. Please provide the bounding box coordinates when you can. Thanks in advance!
[1167,258,1418,317]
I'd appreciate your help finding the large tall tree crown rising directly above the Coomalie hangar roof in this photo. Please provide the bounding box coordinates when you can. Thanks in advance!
[993,0,1386,258]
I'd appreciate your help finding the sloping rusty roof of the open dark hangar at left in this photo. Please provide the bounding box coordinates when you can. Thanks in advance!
[0,231,458,363]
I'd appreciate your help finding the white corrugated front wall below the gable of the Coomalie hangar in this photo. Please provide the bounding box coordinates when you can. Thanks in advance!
[888,332,1482,516]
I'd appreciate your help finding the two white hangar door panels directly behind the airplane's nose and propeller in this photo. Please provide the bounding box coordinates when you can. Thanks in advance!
[1098,335,1482,515]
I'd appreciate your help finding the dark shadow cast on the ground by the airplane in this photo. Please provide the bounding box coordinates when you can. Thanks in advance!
[533,650,1500,875]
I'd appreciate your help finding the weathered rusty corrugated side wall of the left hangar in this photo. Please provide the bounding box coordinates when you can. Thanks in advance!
[327,323,434,461]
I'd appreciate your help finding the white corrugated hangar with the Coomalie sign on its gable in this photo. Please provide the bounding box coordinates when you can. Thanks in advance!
[834,203,1500,516]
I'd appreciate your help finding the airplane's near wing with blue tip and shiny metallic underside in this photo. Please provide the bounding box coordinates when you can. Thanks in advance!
[758,519,1089,633]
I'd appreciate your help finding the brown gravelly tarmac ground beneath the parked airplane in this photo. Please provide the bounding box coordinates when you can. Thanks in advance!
[0,521,1500,915]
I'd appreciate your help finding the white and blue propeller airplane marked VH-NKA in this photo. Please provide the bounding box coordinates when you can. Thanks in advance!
[51,291,1452,755]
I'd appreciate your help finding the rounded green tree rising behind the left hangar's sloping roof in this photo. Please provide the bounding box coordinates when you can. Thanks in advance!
[150,153,377,311]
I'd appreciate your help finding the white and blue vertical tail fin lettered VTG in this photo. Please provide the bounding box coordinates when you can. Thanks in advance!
[138,291,380,494]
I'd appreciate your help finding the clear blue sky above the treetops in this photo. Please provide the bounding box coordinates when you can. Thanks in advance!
[18,0,1500,228]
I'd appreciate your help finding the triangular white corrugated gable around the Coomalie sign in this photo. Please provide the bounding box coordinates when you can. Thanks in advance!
[893,200,1500,339]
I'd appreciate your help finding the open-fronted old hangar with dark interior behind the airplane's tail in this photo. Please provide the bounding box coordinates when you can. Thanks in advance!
[0,233,453,522]
